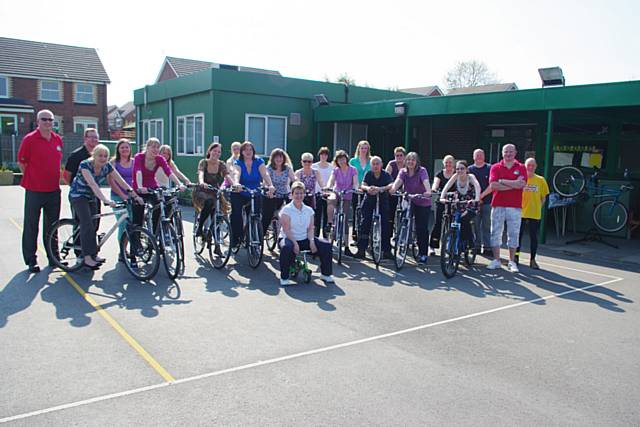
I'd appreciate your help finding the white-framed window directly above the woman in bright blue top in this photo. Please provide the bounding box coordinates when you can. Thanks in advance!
[245,114,287,155]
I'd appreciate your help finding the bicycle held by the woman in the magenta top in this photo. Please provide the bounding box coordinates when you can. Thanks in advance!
[144,188,184,279]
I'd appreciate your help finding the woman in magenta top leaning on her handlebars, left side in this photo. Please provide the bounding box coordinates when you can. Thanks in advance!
[132,138,186,229]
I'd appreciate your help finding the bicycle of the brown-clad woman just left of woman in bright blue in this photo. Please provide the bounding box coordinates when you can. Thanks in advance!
[193,184,231,269]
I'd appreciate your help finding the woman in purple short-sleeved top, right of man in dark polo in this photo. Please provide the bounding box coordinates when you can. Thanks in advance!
[391,152,431,264]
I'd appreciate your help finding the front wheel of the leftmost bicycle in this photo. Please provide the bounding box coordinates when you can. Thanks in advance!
[120,226,160,281]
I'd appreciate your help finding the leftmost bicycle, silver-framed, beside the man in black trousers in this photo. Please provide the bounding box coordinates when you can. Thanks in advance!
[45,197,160,281]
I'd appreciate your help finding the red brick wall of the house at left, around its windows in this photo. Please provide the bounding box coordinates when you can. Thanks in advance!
[11,77,108,138]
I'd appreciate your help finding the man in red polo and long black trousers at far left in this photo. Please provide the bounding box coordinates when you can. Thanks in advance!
[18,110,62,273]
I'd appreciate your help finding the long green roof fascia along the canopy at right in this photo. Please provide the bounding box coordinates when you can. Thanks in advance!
[315,81,640,122]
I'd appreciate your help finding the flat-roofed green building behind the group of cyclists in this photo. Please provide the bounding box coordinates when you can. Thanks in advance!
[134,68,640,242]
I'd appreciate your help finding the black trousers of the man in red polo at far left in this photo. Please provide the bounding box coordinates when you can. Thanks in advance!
[22,190,60,265]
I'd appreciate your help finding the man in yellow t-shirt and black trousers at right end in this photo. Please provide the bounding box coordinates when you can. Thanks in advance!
[516,157,549,270]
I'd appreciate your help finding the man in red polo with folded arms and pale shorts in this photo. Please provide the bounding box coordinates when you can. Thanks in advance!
[487,144,527,273]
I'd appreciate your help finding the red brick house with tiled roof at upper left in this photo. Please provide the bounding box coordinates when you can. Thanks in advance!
[0,37,110,136]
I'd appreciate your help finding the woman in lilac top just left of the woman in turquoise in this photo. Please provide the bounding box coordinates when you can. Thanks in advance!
[327,150,358,256]
